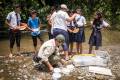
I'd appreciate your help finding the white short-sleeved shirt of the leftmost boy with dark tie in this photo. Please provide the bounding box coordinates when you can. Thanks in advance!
[6,11,21,29]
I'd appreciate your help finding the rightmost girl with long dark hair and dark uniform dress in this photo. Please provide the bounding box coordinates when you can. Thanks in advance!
[89,12,109,54]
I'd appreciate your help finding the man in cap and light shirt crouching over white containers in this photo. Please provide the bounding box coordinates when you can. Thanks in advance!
[33,34,65,71]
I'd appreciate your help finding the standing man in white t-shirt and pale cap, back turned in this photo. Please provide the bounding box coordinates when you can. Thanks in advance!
[52,4,76,59]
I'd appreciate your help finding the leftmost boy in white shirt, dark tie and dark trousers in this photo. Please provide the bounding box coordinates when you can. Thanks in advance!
[6,4,21,57]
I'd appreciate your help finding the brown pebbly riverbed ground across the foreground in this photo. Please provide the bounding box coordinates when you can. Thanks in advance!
[0,45,120,80]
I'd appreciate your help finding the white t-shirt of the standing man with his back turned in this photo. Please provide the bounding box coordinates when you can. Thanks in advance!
[53,10,69,31]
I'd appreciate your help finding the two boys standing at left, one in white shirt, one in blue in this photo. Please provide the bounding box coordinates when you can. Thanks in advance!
[6,4,44,56]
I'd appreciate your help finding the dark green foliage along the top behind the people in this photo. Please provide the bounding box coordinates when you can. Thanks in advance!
[0,0,120,28]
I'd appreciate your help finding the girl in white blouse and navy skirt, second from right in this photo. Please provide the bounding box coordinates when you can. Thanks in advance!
[75,9,86,54]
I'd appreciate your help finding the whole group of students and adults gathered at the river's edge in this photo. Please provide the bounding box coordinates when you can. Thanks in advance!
[6,4,109,71]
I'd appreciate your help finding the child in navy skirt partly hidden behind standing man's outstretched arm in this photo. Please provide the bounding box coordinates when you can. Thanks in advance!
[67,11,75,54]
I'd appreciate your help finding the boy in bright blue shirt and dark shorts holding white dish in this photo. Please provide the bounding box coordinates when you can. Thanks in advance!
[28,10,43,52]
